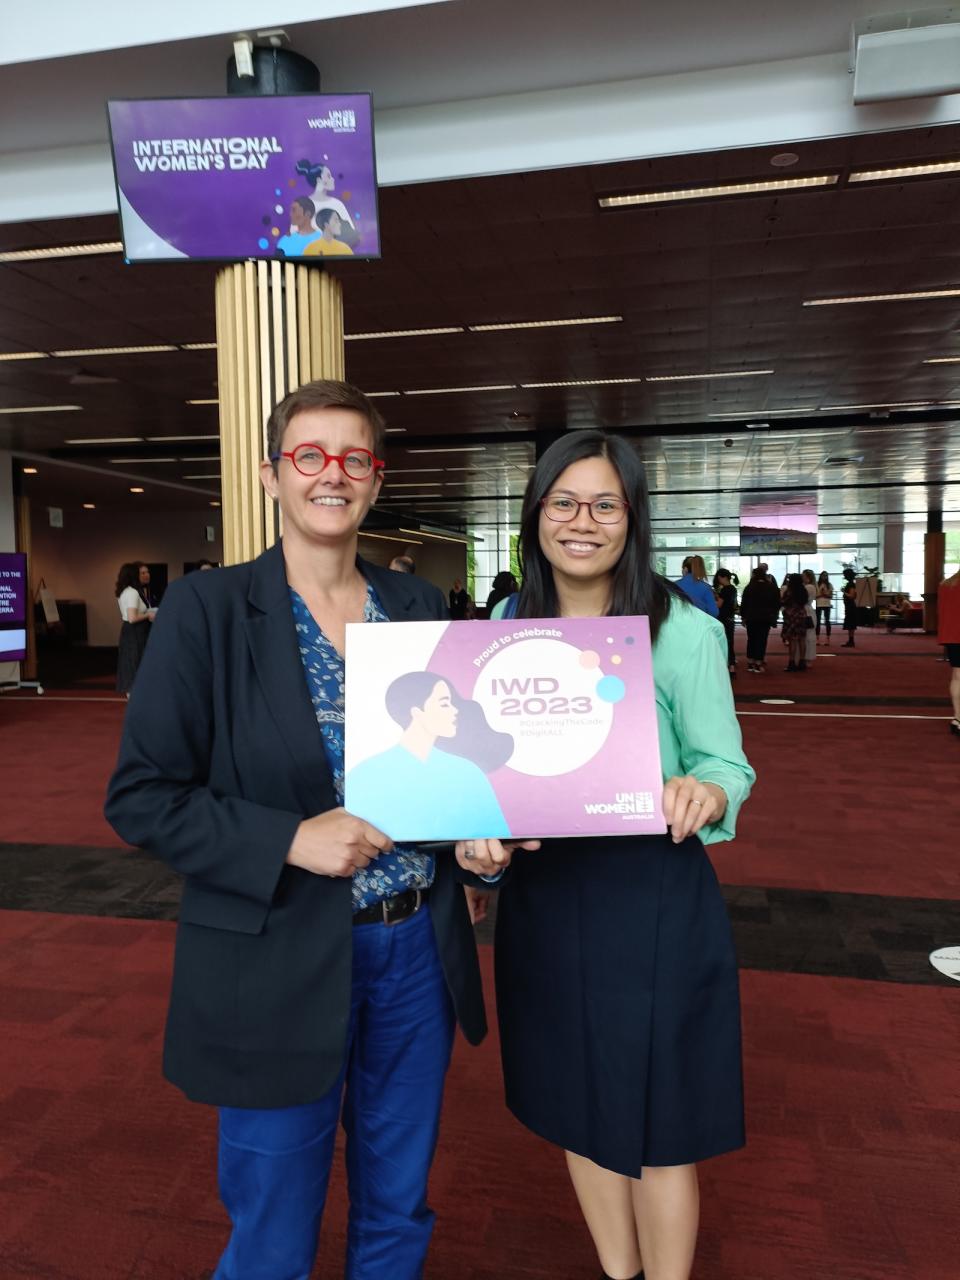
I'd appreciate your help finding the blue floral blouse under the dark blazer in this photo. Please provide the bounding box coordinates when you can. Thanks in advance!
[289,584,434,911]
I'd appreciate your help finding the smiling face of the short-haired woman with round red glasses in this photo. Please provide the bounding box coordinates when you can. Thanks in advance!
[260,408,383,545]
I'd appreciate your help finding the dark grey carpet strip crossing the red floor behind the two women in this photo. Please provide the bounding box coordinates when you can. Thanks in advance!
[0,844,960,987]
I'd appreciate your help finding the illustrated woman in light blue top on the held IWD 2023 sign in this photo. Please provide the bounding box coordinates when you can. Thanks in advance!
[347,671,513,840]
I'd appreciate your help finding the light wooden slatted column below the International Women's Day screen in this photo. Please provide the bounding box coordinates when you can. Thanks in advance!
[215,261,344,564]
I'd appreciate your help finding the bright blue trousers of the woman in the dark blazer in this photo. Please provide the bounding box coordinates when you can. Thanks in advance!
[214,908,453,1280]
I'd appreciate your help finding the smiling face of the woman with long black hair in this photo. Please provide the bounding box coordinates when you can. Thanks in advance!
[539,457,630,584]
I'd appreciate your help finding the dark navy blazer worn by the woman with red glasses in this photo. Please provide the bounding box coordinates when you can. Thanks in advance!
[105,545,486,1107]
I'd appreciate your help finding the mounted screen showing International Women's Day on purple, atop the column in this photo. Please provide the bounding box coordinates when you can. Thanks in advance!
[108,93,380,262]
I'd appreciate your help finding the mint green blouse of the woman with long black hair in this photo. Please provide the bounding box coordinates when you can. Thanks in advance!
[493,598,756,845]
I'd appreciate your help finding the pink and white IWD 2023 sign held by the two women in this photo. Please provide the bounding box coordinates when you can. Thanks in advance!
[344,618,666,841]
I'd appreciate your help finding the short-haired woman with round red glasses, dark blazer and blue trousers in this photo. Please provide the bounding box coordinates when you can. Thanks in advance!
[106,381,535,1280]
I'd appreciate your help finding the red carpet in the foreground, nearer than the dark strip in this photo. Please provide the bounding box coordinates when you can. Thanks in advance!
[0,913,960,1280]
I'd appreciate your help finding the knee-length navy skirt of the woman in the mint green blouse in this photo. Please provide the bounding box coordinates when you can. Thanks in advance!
[495,836,745,1178]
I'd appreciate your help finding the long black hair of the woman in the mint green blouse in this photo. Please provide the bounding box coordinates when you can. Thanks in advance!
[517,430,682,640]
